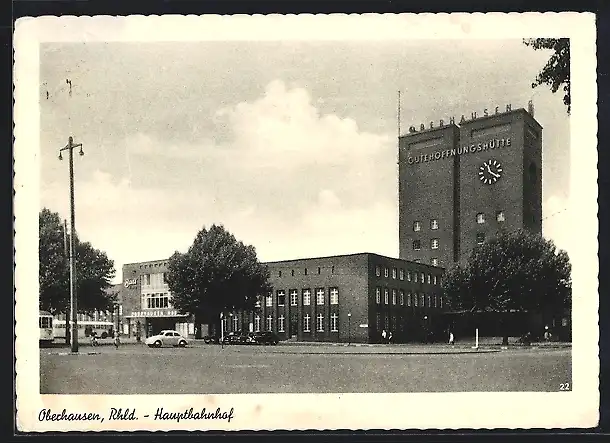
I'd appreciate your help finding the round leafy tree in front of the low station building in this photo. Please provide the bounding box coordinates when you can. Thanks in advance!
[166,225,271,338]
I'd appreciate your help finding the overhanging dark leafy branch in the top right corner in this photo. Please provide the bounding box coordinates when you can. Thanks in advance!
[523,38,571,114]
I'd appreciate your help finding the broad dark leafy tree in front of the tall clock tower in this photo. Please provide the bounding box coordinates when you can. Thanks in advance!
[443,230,572,344]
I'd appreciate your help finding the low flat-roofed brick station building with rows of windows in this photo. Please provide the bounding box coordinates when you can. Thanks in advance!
[122,253,444,343]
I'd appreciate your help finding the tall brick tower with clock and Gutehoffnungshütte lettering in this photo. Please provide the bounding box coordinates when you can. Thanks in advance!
[398,105,542,267]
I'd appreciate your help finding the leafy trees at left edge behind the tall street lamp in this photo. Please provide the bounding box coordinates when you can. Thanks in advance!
[38,208,116,340]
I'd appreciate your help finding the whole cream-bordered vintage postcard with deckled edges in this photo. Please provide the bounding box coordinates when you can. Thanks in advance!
[14,13,599,432]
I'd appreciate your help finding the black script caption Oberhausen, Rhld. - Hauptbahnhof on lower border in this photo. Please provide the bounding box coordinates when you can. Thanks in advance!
[38,408,234,423]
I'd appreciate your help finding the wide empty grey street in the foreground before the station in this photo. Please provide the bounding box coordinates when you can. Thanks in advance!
[40,344,572,394]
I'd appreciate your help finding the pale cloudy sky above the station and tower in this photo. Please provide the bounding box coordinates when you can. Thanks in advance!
[39,39,570,282]
